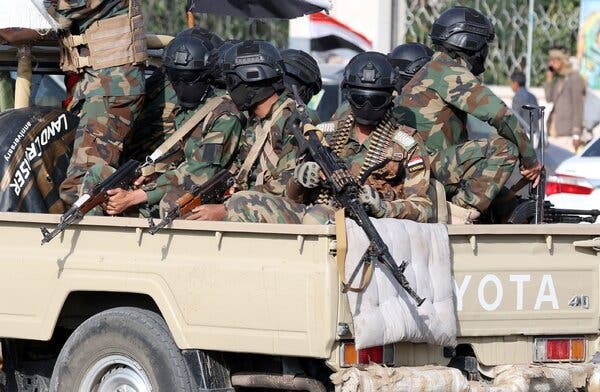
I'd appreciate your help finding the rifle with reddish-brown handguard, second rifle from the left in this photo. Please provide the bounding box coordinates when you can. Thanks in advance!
[148,169,234,235]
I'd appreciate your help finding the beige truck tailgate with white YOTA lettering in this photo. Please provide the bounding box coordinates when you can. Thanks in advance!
[449,225,600,336]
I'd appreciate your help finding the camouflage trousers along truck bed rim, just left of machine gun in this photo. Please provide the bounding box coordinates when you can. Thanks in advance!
[223,191,335,224]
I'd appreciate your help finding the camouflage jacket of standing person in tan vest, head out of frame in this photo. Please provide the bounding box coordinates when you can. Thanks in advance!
[49,0,144,101]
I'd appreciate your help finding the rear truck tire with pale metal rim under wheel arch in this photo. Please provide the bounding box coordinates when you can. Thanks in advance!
[50,307,192,392]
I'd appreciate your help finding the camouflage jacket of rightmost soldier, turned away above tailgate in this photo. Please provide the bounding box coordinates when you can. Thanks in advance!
[399,52,536,167]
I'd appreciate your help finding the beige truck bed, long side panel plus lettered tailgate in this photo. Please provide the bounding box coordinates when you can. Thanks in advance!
[0,213,600,365]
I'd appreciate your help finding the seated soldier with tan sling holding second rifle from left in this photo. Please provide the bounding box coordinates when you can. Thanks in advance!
[186,41,318,223]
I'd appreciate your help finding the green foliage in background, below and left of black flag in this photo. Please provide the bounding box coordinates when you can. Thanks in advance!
[142,0,289,48]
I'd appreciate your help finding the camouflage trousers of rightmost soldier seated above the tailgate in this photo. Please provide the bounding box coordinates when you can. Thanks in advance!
[431,137,518,211]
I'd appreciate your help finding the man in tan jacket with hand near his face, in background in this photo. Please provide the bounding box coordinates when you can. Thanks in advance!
[544,48,585,151]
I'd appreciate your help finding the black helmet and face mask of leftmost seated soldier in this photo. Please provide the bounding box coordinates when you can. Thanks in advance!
[163,29,211,108]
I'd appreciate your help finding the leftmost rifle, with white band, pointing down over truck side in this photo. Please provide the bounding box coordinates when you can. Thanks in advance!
[40,159,144,245]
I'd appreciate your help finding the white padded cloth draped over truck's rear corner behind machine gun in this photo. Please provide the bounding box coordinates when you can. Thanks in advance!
[346,219,456,349]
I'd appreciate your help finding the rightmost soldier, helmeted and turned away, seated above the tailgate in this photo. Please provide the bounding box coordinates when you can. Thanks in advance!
[400,7,541,218]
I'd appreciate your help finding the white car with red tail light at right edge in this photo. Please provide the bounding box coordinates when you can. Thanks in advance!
[546,138,600,219]
